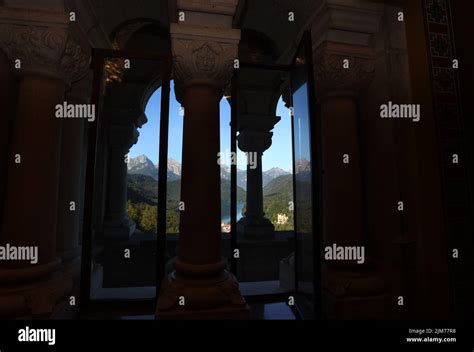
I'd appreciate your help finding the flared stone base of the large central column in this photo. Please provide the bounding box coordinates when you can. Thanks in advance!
[155,259,250,320]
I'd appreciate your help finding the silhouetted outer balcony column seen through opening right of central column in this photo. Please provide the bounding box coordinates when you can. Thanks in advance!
[237,113,281,239]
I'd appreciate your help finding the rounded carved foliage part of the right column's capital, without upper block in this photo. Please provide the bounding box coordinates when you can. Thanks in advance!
[313,43,375,96]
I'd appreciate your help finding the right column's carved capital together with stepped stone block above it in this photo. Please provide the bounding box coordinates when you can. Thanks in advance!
[311,0,385,96]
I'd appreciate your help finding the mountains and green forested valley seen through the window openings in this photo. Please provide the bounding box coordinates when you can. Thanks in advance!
[127,155,293,233]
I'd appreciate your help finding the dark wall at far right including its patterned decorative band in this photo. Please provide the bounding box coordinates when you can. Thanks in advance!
[405,0,474,318]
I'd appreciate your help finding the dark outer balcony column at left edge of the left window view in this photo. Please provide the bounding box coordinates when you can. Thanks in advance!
[104,125,138,241]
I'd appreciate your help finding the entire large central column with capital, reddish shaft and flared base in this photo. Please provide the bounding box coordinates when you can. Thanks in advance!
[156,1,248,319]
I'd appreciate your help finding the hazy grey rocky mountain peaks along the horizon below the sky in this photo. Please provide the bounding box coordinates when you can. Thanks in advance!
[128,155,292,189]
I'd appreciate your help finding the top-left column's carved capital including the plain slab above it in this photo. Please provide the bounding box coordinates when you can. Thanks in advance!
[0,7,90,84]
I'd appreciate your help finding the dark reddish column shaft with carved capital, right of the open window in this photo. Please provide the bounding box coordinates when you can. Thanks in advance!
[314,43,374,249]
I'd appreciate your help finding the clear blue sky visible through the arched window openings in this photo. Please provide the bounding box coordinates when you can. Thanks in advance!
[130,82,292,171]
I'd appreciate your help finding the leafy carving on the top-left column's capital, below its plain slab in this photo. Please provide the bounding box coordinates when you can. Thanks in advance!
[0,24,90,83]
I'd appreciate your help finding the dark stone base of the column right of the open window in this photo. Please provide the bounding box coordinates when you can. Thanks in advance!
[322,264,396,320]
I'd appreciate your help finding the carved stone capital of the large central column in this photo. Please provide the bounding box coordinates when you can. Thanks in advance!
[170,23,240,100]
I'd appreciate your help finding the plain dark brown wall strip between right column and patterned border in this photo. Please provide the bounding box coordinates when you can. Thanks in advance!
[404,0,453,319]
